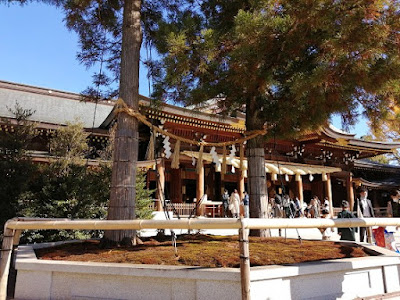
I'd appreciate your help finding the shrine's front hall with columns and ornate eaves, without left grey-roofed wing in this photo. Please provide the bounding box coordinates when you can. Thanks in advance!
[126,98,400,213]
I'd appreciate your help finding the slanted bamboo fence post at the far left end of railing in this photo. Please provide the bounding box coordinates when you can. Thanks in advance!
[0,223,19,300]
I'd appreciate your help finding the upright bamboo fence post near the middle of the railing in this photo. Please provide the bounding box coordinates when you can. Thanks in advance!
[239,218,250,300]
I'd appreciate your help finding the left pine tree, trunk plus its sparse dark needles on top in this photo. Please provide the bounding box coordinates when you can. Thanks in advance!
[0,0,176,243]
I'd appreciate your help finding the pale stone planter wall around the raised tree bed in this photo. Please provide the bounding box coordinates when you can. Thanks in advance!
[15,245,400,300]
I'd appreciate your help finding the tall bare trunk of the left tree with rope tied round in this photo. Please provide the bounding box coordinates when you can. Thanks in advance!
[105,0,142,243]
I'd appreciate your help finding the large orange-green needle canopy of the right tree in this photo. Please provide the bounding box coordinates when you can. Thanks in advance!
[150,0,400,137]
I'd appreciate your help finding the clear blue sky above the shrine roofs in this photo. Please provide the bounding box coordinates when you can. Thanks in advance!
[0,3,368,137]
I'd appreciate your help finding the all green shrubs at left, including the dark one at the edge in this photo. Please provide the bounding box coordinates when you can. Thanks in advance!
[0,116,153,242]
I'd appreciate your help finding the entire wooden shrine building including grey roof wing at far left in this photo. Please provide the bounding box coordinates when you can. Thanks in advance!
[0,81,400,216]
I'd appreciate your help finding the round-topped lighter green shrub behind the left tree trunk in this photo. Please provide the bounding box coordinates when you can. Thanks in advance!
[18,123,153,242]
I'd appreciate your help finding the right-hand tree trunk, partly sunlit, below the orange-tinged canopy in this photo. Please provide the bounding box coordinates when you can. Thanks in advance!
[246,98,270,237]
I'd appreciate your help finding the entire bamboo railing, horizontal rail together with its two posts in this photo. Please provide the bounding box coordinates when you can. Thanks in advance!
[0,218,400,300]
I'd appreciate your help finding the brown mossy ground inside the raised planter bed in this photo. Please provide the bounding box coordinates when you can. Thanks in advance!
[36,235,369,268]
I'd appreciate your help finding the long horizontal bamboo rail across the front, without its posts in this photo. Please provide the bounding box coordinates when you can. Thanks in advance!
[5,218,400,230]
